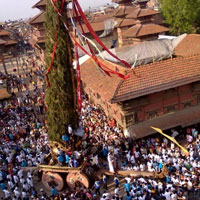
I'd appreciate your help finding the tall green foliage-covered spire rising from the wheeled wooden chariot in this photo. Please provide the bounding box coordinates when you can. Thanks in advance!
[45,0,78,141]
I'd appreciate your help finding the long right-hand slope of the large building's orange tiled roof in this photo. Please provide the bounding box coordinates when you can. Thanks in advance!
[112,55,200,102]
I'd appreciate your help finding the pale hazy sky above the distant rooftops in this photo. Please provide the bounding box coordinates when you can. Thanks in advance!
[0,0,111,22]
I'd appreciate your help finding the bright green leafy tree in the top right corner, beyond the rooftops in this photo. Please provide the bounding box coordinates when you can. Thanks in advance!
[160,0,200,35]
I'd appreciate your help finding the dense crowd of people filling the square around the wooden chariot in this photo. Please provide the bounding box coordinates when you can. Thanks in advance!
[0,56,200,200]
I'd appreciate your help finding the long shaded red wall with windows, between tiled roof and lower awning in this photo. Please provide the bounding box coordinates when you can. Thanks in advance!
[122,82,200,126]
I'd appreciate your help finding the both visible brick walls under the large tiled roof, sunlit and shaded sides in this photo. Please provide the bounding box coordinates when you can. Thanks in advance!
[83,82,200,133]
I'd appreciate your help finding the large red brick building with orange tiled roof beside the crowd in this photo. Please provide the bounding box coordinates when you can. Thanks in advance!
[81,35,200,139]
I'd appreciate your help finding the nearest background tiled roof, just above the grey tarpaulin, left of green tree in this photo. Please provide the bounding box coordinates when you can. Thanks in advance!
[122,24,169,37]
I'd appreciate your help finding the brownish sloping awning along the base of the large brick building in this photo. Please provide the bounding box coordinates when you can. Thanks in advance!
[126,105,200,139]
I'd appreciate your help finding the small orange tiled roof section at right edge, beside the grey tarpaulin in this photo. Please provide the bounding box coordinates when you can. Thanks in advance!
[174,34,200,56]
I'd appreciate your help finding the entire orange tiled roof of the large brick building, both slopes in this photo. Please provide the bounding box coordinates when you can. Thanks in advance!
[81,55,200,103]
